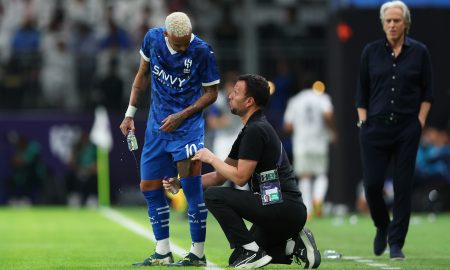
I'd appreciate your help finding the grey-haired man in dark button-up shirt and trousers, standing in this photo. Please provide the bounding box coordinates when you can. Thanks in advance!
[356,1,433,260]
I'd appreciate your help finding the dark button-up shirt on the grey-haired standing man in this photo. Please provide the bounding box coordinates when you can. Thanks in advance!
[356,37,433,118]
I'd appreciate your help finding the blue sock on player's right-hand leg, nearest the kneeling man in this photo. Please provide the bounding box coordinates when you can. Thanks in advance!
[180,176,208,243]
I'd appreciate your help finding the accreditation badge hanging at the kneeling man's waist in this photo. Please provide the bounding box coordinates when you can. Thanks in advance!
[259,169,283,205]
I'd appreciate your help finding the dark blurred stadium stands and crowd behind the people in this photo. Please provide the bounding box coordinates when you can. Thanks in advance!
[0,0,450,212]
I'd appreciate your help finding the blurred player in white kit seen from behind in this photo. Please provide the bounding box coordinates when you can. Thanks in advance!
[283,82,336,218]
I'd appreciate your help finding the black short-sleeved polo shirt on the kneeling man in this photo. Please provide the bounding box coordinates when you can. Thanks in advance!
[228,110,300,195]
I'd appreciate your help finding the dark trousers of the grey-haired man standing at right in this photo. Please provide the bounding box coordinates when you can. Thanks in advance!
[360,117,422,248]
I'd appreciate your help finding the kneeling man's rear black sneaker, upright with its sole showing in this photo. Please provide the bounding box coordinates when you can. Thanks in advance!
[293,228,320,269]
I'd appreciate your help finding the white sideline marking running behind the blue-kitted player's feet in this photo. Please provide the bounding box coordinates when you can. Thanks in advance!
[100,207,223,269]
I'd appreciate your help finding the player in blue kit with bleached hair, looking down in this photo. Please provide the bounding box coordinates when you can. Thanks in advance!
[120,12,220,266]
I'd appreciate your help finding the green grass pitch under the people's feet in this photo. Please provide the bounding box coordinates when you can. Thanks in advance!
[0,207,450,270]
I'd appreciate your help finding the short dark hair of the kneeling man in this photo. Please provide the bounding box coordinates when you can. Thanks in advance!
[237,74,270,108]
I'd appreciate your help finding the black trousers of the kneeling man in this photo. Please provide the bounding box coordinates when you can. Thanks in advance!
[204,187,306,264]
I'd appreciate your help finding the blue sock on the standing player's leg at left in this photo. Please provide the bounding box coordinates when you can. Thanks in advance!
[142,188,170,240]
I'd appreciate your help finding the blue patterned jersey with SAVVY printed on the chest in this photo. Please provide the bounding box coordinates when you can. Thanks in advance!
[140,28,220,140]
